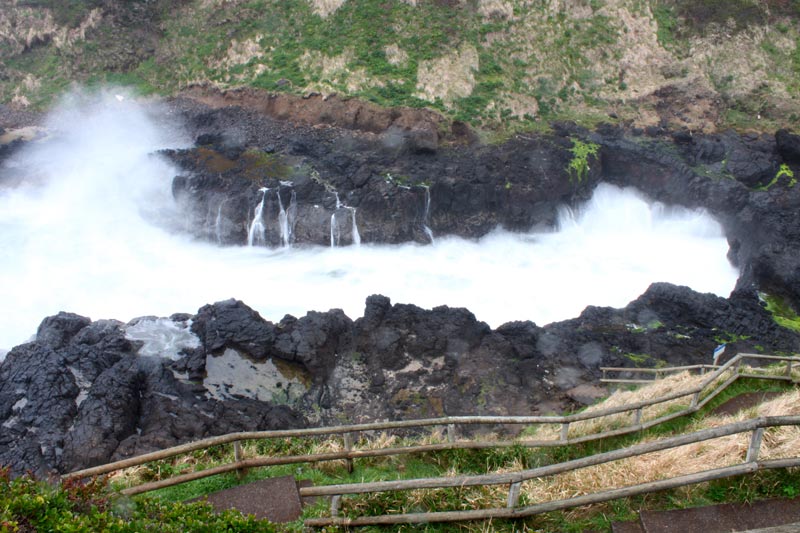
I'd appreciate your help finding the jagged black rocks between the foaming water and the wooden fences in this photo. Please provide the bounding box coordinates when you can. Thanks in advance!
[0,283,800,474]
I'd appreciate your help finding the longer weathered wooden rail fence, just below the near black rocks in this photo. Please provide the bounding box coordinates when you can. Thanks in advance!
[62,354,800,512]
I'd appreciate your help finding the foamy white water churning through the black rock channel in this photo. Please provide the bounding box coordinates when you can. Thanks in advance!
[0,91,738,348]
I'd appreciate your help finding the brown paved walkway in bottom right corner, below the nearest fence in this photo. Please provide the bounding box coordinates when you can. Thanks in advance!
[611,498,800,533]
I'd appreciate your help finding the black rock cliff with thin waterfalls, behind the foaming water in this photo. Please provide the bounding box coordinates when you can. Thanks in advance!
[162,92,800,307]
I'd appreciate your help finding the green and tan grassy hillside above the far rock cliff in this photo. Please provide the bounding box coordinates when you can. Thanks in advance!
[0,0,800,129]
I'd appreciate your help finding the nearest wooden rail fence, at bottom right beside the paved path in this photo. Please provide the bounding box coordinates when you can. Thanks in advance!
[300,416,800,527]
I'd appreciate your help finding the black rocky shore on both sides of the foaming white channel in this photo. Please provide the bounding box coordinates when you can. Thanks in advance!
[0,94,800,475]
